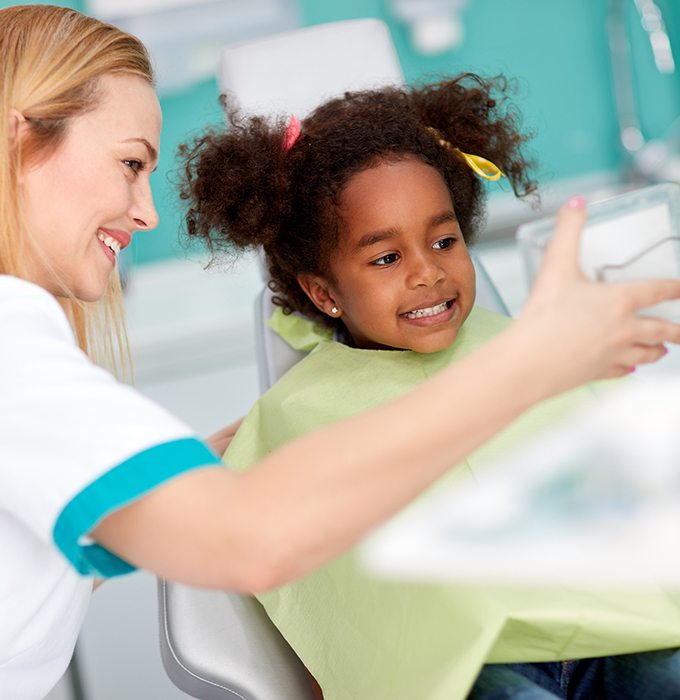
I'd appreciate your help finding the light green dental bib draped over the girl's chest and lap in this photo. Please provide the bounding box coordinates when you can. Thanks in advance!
[225,308,680,700]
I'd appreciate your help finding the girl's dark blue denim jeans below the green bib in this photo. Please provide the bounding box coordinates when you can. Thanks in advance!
[468,649,680,700]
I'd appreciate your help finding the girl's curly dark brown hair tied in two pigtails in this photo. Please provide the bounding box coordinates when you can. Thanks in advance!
[180,73,536,327]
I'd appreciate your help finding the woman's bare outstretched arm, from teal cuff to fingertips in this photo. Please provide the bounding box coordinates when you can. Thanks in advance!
[93,199,680,592]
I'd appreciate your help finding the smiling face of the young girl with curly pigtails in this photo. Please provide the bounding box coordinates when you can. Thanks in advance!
[301,158,475,353]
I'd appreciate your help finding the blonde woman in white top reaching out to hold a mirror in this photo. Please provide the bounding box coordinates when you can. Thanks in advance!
[0,6,680,698]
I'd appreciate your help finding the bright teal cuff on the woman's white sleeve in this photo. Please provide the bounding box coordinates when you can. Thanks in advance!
[53,438,221,578]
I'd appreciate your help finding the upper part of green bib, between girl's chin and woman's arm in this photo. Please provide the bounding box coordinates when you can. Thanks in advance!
[225,309,510,469]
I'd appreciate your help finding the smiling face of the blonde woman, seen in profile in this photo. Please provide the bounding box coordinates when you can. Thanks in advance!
[18,74,161,301]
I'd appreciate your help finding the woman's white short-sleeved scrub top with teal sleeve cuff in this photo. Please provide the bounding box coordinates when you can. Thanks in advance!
[0,275,220,700]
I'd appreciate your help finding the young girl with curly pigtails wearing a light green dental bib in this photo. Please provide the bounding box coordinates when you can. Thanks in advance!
[184,75,680,700]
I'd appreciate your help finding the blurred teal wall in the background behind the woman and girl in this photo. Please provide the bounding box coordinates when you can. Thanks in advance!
[5,0,680,263]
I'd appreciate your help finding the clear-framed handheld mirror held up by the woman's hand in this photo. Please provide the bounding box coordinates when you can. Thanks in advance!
[516,183,680,321]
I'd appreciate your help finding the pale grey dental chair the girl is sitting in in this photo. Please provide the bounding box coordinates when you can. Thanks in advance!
[159,19,508,700]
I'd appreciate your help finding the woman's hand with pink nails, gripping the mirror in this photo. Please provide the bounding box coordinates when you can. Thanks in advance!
[517,197,680,390]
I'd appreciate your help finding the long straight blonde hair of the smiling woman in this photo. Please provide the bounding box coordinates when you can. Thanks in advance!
[0,5,154,374]
